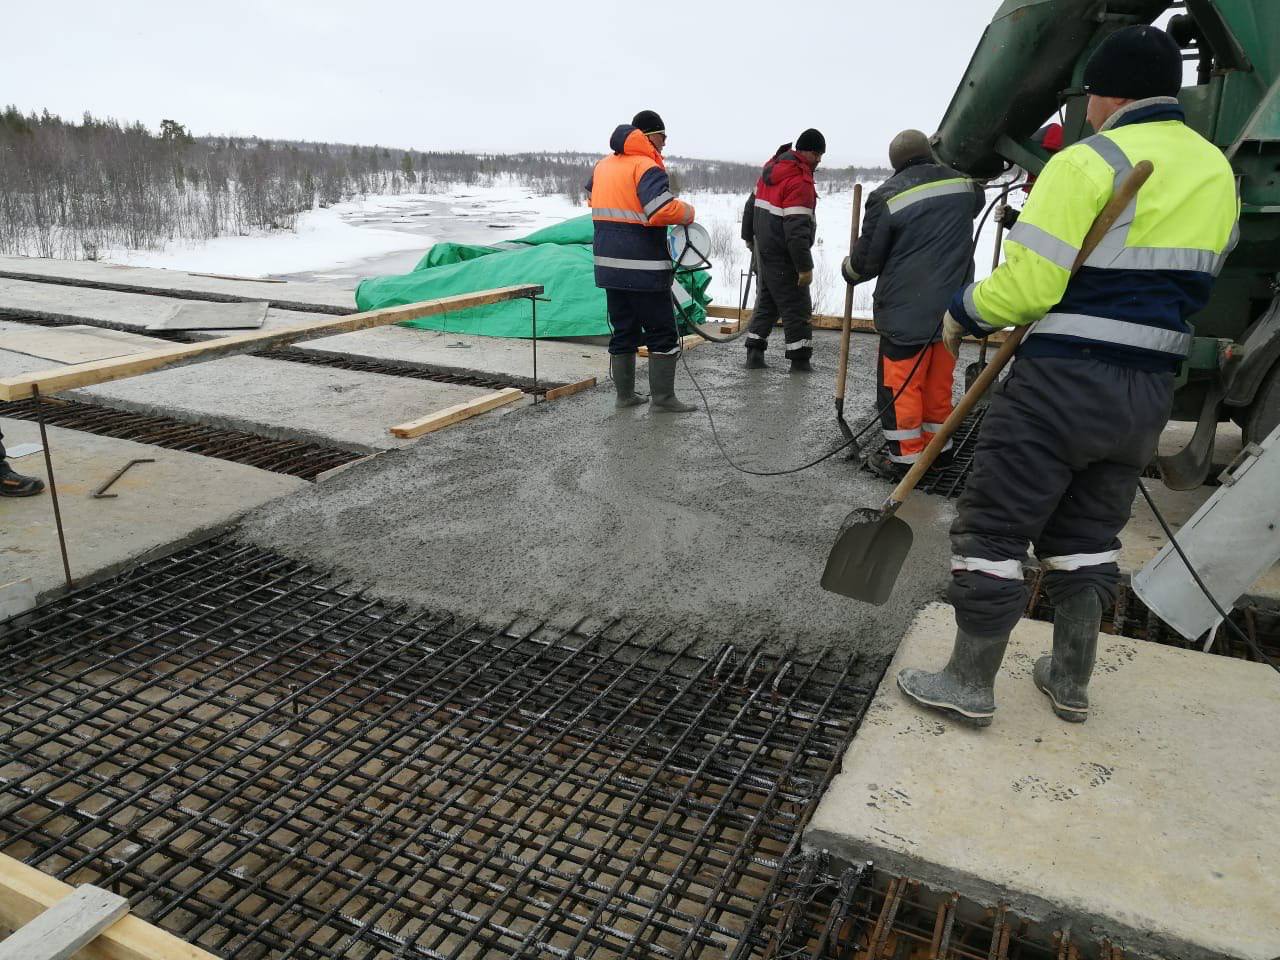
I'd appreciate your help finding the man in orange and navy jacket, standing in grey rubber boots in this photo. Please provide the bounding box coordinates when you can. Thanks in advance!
[588,110,694,413]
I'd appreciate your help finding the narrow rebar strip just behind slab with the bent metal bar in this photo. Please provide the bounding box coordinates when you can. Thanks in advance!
[0,397,364,480]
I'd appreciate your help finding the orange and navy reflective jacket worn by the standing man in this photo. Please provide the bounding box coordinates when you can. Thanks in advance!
[589,124,694,291]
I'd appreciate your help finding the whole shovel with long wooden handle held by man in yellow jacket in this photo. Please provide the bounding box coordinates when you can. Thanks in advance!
[822,160,1153,604]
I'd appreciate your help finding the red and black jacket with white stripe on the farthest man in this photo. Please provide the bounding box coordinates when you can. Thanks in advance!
[742,147,818,273]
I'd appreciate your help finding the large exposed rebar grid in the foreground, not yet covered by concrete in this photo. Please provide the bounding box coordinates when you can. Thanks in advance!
[0,538,876,960]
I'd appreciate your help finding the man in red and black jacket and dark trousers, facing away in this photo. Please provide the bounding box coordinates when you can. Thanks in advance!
[742,129,827,371]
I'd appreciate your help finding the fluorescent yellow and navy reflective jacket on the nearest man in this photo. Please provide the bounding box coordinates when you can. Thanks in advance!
[951,97,1240,370]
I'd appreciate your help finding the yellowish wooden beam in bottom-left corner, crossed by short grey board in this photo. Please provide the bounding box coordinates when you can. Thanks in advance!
[0,854,218,960]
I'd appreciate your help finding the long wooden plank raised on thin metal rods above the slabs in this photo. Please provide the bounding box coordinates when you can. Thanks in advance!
[0,284,543,401]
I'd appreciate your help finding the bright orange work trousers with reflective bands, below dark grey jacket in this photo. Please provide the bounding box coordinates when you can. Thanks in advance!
[876,337,956,463]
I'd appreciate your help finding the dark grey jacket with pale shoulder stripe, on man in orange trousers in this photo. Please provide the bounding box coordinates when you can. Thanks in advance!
[845,159,984,347]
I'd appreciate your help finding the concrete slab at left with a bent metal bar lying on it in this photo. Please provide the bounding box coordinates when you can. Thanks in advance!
[0,417,310,596]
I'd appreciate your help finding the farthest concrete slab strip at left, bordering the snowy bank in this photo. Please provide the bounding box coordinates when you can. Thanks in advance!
[0,256,356,312]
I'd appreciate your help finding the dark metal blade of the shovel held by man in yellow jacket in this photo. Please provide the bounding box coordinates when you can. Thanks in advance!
[822,507,911,605]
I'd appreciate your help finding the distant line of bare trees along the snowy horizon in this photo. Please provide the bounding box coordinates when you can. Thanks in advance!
[0,106,887,260]
